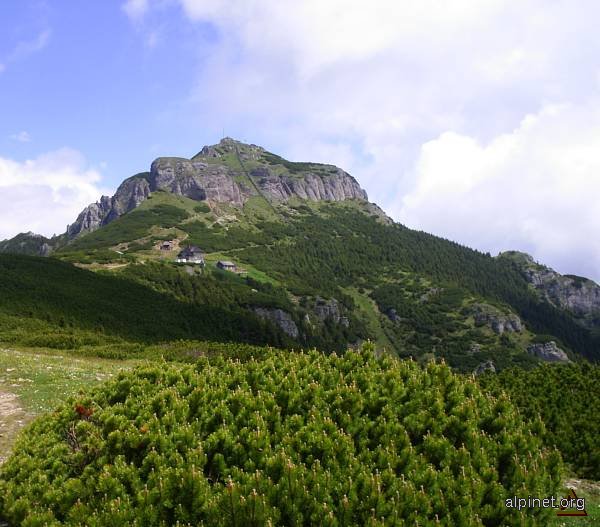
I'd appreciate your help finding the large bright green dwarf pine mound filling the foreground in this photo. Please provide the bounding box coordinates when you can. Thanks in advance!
[0,347,560,526]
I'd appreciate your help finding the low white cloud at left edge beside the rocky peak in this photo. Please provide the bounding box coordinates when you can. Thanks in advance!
[0,148,110,239]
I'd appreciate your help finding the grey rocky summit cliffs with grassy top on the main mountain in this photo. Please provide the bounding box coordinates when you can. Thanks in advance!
[67,138,366,238]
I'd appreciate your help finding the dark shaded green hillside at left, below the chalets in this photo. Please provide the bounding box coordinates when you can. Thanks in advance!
[0,255,291,349]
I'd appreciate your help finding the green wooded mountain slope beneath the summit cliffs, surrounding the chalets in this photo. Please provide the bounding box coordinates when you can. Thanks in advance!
[52,192,600,370]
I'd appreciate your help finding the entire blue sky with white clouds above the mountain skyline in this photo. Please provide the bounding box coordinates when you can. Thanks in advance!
[0,0,600,282]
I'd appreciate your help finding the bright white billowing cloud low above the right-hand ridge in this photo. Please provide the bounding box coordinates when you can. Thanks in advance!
[394,101,600,281]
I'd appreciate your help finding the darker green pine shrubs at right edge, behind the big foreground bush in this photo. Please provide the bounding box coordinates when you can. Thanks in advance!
[479,364,600,480]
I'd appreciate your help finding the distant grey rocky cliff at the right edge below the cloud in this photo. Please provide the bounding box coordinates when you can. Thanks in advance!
[500,251,600,329]
